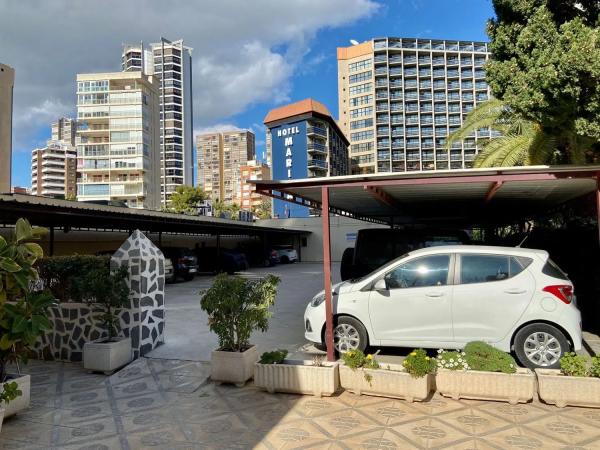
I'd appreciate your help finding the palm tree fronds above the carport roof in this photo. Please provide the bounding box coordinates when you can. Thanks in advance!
[446,99,557,167]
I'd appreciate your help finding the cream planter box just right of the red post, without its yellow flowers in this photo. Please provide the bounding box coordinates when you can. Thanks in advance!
[340,364,433,402]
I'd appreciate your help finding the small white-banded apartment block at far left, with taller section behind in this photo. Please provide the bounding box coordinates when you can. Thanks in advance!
[31,117,77,198]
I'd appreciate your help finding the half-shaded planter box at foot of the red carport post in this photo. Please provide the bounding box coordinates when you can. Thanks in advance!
[254,360,340,397]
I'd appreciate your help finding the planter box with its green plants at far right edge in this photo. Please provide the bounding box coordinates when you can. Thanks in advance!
[535,353,600,408]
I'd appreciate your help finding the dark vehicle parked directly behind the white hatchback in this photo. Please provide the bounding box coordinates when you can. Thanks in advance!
[340,228,470,281]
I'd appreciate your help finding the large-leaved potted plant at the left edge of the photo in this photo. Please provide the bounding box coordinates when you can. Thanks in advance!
[0,219,55,417]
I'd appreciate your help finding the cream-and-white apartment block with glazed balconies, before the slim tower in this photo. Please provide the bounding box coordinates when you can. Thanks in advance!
[76,71,160,209]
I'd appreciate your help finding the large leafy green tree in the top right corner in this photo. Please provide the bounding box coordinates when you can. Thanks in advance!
[486,0,600,163]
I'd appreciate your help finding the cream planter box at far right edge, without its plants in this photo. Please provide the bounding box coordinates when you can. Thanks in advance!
[535,369,600,408]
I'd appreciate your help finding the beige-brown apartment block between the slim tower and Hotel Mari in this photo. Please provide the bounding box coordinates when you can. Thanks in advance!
[196,130,256,203]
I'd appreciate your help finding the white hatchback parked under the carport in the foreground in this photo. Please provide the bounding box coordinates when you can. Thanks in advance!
[304,245,582,368]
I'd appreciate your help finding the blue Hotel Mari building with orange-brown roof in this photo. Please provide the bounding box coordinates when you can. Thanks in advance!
[264,99,350,217]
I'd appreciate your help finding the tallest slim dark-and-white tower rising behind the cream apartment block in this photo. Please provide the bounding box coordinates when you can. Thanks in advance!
[122,39,194,204]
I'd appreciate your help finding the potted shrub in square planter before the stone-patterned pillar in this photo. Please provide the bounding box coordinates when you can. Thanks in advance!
[79,264,132,374]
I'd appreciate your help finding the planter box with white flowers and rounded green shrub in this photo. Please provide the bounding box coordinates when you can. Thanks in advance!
[435,341,535,405]
